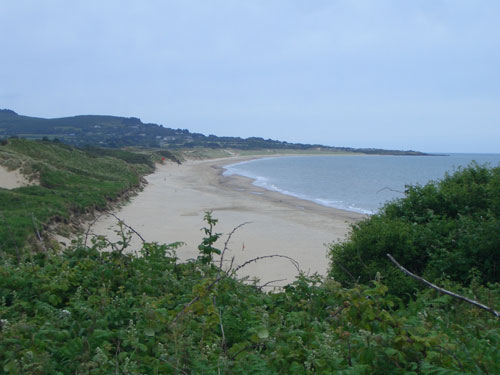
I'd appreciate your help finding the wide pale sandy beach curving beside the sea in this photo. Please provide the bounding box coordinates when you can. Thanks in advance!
[91,157,363,286]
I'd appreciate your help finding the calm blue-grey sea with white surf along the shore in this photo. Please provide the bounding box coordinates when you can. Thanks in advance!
[224,154,500,214]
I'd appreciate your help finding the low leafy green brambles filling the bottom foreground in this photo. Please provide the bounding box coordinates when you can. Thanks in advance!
[0,222,500,375]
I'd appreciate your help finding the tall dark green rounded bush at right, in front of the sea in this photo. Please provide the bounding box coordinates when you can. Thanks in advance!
[331,164,500,296]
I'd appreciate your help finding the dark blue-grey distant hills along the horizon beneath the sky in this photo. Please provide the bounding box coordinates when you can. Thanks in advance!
[0,109,426,155]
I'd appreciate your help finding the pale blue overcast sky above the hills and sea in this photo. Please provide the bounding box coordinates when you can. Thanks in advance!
[0,0,500,153]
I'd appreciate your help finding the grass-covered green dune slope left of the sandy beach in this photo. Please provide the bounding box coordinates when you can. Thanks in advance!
[0,139,152,260]
